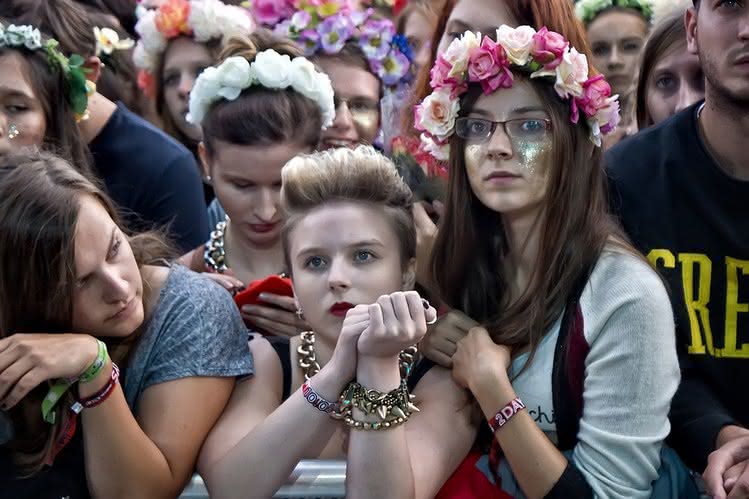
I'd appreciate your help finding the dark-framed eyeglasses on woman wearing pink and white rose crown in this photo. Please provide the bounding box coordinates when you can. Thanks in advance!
[455,117,551,144]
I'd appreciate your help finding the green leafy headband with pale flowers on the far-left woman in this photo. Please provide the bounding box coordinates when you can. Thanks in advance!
[0,23,96,120]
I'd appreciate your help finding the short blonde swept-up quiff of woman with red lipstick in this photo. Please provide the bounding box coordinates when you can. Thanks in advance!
[281,145,416,270]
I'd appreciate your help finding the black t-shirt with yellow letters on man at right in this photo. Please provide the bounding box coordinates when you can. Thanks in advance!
[606,103,749,471]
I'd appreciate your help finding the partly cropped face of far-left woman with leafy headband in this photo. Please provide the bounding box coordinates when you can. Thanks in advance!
[0,50,47,156]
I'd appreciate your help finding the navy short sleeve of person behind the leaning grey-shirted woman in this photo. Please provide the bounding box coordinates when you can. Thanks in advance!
[150,151,209,253]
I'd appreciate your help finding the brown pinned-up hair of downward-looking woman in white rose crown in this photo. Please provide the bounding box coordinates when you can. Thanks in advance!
[202,29,323,156]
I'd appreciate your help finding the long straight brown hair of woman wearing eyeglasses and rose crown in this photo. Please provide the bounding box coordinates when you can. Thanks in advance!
[430,73,628,358]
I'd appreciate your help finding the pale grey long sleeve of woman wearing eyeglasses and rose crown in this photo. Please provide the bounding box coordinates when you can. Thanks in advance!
[572,255,680,499]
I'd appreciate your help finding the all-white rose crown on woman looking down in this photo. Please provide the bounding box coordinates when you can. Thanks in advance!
[187,49,335,128]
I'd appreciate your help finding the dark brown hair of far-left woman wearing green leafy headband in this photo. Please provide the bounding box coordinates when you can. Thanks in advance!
[0,25,91,175]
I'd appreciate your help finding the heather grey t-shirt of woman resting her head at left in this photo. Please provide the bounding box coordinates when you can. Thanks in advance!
[122,264,253,412]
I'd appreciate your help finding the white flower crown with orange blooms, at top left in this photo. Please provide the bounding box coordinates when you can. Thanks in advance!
[133,0,255,97]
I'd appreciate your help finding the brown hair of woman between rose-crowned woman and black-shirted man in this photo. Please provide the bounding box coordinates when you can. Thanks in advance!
[635,10,687,130]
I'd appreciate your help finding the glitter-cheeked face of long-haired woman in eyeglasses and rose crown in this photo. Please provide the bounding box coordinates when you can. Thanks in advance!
[464,79,553,215]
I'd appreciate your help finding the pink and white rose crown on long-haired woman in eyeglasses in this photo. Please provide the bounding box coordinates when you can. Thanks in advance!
[415,25,619,161]
